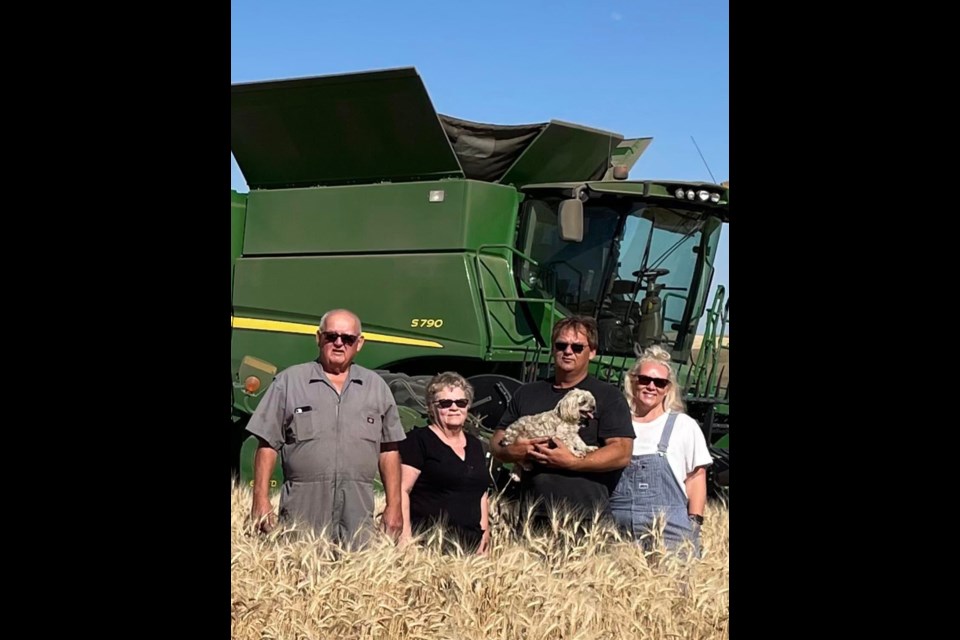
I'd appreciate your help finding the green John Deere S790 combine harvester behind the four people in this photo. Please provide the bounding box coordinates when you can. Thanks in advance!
[231,69,729,490]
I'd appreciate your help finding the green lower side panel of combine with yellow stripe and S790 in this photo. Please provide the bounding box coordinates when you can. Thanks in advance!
[233,253,482,368]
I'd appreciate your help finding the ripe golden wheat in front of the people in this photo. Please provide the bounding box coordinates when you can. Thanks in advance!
[231,486,729,640]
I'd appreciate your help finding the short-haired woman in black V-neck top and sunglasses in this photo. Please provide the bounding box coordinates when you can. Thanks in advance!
[400,372,490,554]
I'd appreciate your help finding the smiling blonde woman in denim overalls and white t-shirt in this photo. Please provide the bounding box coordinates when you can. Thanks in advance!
[610,346,713,558]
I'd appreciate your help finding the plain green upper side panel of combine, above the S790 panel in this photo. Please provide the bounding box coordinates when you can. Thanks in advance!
[244,180,519,256]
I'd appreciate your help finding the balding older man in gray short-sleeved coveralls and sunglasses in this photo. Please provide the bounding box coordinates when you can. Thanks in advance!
[247,309,405,544]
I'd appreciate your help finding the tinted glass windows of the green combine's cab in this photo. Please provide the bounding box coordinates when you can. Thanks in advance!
[520,197,719,353]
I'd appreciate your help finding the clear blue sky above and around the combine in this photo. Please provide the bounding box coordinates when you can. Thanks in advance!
[231,0,730,328]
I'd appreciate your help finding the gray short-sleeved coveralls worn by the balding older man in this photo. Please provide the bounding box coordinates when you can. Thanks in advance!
[247,361,405,544]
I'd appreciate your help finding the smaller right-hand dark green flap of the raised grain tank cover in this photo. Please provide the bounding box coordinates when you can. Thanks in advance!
[500,120,623,186]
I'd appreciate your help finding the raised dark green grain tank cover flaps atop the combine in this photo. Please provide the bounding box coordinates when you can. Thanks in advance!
[231,68,623,189]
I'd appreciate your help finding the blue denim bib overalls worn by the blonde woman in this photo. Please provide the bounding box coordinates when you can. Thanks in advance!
[610,412,700,558]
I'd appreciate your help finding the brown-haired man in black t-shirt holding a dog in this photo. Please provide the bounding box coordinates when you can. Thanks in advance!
[491,317,636,525]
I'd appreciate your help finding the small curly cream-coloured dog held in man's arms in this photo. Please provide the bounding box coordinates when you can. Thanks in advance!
[500,389,599,471]
